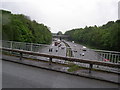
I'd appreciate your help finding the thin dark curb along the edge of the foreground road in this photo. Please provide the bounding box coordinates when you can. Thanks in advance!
[2,59,120,84]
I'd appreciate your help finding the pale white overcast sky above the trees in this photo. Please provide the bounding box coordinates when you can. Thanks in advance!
[0,0,119,33]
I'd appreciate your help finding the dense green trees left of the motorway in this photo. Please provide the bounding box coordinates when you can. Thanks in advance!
[1,10,52,44]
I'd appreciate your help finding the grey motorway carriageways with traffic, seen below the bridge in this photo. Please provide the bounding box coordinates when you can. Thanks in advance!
[34,40,100,61]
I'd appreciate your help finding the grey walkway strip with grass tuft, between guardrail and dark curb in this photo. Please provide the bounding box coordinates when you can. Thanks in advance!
[2,55,119,88]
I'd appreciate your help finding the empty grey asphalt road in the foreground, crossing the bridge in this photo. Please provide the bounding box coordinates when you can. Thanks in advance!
[2,61,118,88]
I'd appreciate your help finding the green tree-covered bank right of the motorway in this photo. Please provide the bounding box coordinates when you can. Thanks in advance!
[65,20,120,51]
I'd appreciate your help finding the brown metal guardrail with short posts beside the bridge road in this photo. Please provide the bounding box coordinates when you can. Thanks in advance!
[0,48,120,73]
